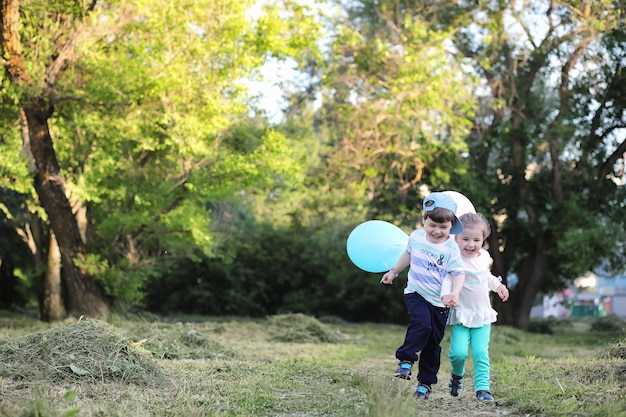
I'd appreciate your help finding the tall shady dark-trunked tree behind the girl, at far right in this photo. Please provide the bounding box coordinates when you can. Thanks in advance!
[447,1,626,328]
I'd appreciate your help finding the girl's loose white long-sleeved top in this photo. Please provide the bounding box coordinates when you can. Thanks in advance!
[441,249,500,328]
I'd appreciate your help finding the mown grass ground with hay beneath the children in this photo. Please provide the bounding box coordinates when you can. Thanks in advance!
[0,313,626,417]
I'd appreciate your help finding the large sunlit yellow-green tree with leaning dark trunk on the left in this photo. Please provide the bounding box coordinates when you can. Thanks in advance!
[2,0,326,315]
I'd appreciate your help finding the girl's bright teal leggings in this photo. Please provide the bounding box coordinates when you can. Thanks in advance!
[448,324,491,391]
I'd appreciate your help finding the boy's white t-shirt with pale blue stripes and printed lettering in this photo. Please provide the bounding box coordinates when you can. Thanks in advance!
[404,230,465,307]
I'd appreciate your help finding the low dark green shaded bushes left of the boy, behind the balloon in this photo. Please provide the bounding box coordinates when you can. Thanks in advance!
[141,219,406,322]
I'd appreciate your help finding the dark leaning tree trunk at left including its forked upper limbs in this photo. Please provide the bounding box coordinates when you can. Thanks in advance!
[0,0,109,316]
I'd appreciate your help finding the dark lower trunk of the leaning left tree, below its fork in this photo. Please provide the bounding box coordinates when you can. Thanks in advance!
[23,98,109,317]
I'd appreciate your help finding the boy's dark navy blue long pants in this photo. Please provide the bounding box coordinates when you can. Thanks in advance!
[396,293,449,385]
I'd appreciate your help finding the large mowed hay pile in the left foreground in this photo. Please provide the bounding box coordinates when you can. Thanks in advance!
[0,319,170,386]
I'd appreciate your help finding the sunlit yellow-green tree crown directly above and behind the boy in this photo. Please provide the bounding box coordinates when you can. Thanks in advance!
[308,1,475,227]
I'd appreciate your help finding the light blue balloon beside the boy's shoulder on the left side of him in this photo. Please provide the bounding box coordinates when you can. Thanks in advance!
[346,220,409,273]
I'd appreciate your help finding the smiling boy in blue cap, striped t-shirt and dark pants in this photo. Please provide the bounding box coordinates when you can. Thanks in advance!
[380,193,465,400]
